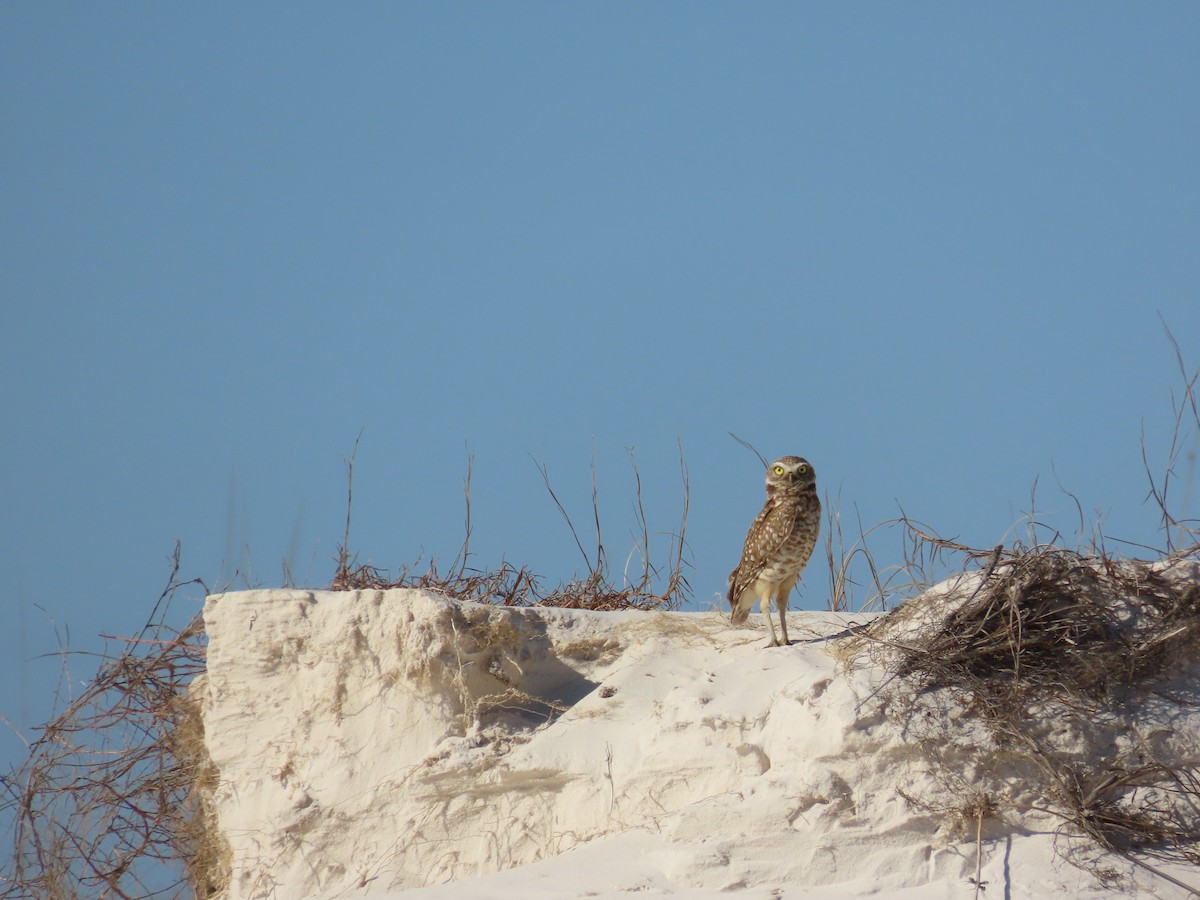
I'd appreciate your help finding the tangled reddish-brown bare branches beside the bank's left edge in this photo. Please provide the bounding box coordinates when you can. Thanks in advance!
[0,546,227,898]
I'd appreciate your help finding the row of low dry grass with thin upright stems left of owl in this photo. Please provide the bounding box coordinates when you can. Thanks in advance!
[330,442,690,611]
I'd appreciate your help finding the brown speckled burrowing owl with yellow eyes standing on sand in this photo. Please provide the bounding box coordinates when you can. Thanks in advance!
[730,456,821,647]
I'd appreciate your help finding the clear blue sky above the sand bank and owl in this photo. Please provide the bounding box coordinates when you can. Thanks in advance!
[0,2,1200,772]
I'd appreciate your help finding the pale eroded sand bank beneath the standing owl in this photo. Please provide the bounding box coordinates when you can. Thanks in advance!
[197,590,1187,898]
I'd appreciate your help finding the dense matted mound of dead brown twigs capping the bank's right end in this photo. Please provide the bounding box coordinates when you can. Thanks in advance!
[872,546,1200,700]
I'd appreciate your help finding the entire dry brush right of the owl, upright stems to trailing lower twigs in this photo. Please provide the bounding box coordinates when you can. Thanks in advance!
[839,336,1200,895]
